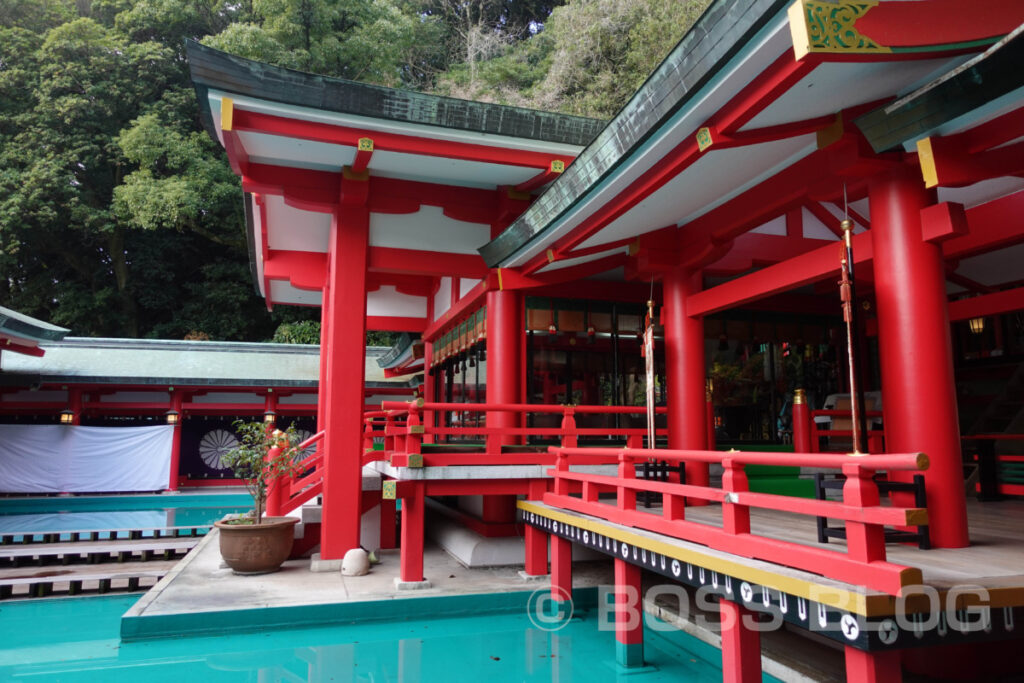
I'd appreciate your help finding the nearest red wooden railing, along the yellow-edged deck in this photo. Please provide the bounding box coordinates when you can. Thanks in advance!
[544,447,928,595]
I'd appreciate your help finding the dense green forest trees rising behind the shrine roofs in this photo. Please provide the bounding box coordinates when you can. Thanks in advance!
[0,0,708,341]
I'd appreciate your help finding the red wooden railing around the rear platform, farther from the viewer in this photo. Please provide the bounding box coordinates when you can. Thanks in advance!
[364,399,667,467]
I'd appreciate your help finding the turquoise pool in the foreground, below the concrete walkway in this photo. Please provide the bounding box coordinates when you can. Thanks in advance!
[0,596,775,683]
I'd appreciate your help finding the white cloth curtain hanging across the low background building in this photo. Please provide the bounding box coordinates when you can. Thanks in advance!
[0,425,174,494]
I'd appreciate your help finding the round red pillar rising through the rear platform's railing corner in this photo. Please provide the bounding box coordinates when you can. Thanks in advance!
[483,290,523,523]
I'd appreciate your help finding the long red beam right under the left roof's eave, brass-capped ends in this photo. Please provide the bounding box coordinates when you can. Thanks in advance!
[228,108,564,169]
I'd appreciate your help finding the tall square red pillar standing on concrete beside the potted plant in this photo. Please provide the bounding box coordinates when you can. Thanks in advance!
[321,197,370,560]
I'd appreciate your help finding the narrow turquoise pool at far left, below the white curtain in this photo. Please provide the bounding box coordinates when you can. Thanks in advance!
[0,493,252,540]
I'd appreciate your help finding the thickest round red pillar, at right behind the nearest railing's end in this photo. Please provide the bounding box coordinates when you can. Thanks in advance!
[869,167,968,548]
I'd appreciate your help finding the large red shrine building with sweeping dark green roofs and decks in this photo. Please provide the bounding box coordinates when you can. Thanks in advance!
[188,0,1024,680]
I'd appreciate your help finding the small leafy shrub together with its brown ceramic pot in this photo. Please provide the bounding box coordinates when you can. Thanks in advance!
[214,420,301,574]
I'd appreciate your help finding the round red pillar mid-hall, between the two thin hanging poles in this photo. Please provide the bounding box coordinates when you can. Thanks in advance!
[663,268,709,497]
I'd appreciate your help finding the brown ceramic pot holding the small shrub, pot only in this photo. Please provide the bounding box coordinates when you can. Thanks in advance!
[214,517,299,573]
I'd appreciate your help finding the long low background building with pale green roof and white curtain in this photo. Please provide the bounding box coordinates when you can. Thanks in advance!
[0,327,416,494]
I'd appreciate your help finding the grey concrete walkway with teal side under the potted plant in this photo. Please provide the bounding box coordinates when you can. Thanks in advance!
[121,529,612,640]
